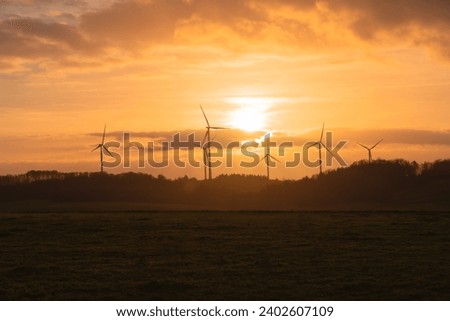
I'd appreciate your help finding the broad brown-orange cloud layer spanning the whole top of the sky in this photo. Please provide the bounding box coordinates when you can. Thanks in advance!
[0,0,450,70]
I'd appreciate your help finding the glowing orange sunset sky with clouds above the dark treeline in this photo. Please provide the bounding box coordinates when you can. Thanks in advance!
[0,0,450,178]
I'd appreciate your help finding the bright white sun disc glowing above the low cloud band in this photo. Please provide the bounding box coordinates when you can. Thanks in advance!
[228,97,271,132]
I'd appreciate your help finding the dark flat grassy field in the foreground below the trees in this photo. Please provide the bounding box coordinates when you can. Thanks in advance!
[0,212,450,300]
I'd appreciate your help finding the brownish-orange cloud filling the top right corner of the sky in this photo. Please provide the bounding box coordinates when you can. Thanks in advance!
[324,0,450,59]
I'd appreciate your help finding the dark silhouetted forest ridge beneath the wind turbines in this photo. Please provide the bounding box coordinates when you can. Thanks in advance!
[0,160,450,210]
